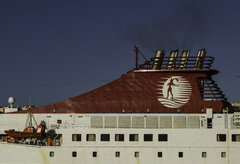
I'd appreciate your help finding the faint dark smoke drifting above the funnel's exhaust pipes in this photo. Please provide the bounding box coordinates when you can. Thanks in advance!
[121,0,218,51]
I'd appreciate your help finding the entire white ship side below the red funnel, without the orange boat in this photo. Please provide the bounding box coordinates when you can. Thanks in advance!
[0,110,240,164]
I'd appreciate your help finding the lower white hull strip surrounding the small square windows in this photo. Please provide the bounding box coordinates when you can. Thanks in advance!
[0,144,236,164]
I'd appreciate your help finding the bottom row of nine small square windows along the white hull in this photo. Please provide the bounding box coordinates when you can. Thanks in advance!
[49,151,226,158]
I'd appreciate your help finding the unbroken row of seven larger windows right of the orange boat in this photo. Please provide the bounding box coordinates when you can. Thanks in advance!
[72,134,168,142]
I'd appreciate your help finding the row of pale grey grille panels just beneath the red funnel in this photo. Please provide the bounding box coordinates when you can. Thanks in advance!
[91,115,200,129]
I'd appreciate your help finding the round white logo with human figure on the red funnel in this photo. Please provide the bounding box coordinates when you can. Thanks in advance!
[158,76,192,108]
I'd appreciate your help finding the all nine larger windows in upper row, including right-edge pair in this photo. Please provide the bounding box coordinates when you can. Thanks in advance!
[72,134,240,142]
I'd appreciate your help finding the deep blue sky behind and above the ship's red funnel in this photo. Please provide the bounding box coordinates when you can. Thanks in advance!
[0,0,240,106]
